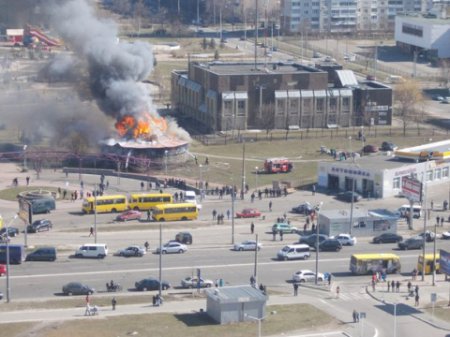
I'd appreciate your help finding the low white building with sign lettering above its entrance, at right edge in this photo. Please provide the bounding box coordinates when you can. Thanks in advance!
[317,140,450,198]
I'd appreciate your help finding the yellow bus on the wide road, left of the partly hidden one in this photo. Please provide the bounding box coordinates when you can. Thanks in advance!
[350,253,401,275]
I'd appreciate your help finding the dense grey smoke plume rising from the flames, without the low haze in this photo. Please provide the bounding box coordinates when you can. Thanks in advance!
[49,0,189,140]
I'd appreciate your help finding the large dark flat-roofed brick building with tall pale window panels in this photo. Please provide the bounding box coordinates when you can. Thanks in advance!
[172,61,392,132]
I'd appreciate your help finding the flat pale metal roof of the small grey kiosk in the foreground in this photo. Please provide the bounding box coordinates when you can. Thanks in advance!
[206,285,267,303]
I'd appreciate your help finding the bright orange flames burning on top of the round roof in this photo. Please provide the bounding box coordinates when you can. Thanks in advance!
[115,113,167,139]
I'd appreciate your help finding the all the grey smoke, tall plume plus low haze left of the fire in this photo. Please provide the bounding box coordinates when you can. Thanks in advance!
[0,0,189,147]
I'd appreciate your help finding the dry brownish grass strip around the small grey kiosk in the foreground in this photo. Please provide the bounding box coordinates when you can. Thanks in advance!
[8,304,338,337]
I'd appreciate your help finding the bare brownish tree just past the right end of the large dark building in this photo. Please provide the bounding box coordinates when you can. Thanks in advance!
[394,80,424,136]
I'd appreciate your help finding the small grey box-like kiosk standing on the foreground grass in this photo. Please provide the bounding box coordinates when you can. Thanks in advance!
[206,285,267,324]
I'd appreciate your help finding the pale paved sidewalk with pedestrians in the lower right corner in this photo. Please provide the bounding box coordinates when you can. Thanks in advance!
[366,275,450,331]
